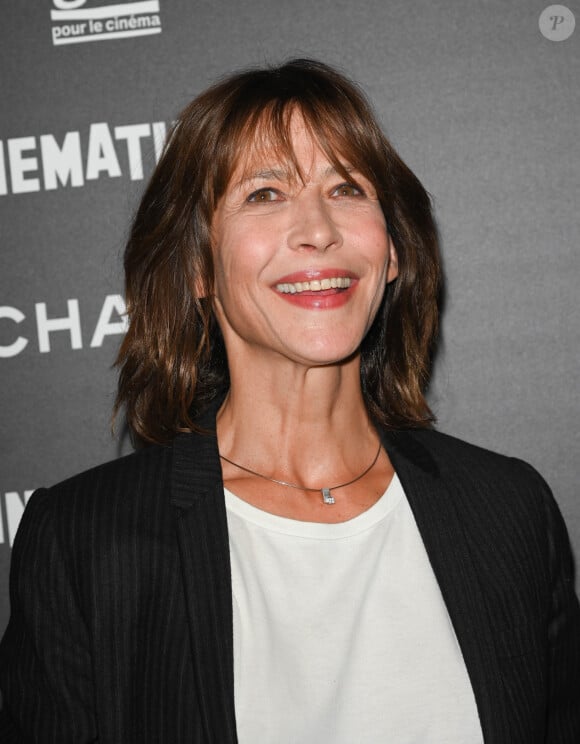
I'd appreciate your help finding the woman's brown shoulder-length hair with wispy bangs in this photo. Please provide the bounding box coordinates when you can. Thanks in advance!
[115,59,440,443]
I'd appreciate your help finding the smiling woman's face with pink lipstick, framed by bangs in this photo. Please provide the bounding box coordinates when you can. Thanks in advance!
[212,114,397,366]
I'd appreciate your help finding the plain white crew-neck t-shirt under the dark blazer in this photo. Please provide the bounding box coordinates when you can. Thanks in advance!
[225,476,483,744]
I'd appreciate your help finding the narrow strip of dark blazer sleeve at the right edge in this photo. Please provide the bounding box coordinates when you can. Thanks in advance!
[541,468,580,744]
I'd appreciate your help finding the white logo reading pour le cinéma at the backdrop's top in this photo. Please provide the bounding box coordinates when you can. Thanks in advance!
[50,0,161,46]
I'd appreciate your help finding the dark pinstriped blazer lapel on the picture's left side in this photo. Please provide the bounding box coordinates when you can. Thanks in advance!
[171,407,237,744]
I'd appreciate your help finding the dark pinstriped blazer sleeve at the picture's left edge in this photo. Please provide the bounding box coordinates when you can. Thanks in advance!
[0,489,98,744]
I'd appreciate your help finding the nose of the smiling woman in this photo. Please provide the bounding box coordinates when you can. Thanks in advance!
[289,194,342,252]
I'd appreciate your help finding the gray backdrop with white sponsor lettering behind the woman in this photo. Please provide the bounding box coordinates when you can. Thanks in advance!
[0,0,580,631]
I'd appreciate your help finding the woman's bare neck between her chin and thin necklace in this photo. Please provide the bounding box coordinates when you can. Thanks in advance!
[217,357,378,483]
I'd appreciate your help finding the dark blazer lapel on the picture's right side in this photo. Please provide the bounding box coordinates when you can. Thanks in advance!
[383,431,509,744]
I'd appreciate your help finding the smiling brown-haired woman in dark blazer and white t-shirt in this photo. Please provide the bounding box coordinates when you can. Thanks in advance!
[0,60,580,744]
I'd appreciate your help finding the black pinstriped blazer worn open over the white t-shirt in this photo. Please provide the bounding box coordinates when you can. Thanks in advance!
[0,410,580,744]
